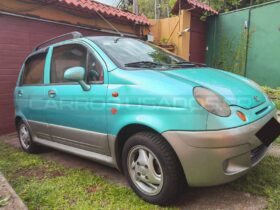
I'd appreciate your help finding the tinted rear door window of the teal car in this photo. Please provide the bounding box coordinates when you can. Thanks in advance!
[22,53,46,85]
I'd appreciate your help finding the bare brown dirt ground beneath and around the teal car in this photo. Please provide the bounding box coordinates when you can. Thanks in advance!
[0,134,272,210]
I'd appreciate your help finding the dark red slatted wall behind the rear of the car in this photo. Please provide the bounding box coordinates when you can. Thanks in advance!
[0,15,108,134]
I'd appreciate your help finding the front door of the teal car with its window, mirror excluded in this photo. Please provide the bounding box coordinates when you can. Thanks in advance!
[45,43,109,154]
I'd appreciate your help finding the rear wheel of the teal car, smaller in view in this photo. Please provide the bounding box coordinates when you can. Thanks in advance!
[17,121,41,153]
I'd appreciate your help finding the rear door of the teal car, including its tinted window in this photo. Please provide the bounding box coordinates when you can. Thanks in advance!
[15,50,49,139]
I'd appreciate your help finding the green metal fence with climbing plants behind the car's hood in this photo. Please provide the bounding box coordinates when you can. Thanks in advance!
[206,0,280,87]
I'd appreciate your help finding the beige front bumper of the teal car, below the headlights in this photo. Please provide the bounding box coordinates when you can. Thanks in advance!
[162,110,276,187]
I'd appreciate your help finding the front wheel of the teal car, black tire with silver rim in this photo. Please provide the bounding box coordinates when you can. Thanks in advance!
[122,132,186,205]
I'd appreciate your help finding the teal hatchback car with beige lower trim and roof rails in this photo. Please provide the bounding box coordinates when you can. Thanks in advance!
[14,32,280,205]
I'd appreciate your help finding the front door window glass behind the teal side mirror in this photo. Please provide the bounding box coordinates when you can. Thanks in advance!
[51,44,87,83]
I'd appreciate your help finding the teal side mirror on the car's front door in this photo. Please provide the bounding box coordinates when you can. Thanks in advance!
[64,66,90,91]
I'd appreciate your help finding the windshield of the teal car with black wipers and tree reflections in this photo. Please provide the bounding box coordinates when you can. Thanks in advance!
[92,37,194,69]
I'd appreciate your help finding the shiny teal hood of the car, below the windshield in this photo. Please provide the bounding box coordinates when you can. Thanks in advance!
[159,68,266,109]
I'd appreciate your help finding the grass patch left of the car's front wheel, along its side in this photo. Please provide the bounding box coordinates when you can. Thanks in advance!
[0,142,173,210]
